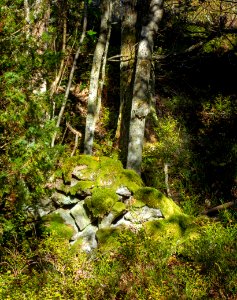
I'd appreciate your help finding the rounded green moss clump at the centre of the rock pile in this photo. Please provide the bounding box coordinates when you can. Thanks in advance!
[85,188,118,217]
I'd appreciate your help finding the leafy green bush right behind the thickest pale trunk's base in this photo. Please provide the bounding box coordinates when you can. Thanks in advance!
[142,116,191,196]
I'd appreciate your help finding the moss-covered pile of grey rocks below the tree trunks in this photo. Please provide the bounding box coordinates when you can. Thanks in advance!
[39,155,180,252]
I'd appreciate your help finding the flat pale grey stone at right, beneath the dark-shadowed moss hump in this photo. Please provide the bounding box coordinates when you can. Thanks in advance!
[124,206,163,223]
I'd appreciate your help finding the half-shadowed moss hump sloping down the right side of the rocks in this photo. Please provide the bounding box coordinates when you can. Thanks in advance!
[134,187,182,218]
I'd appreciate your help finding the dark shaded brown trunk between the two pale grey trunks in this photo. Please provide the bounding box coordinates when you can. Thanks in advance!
[116,0,137,163]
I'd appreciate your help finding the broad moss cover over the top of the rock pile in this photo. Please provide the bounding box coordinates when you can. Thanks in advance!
[54,155,144,195]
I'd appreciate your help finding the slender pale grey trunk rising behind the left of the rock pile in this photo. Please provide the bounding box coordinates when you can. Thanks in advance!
[84,0,112,155]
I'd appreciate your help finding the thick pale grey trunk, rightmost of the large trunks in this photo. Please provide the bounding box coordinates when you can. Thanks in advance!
[127,0,164,174]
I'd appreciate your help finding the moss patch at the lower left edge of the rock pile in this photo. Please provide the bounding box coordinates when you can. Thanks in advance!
[43,213,74,240]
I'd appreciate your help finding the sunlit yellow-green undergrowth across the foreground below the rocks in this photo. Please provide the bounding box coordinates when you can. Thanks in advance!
[0,219,237,300]
